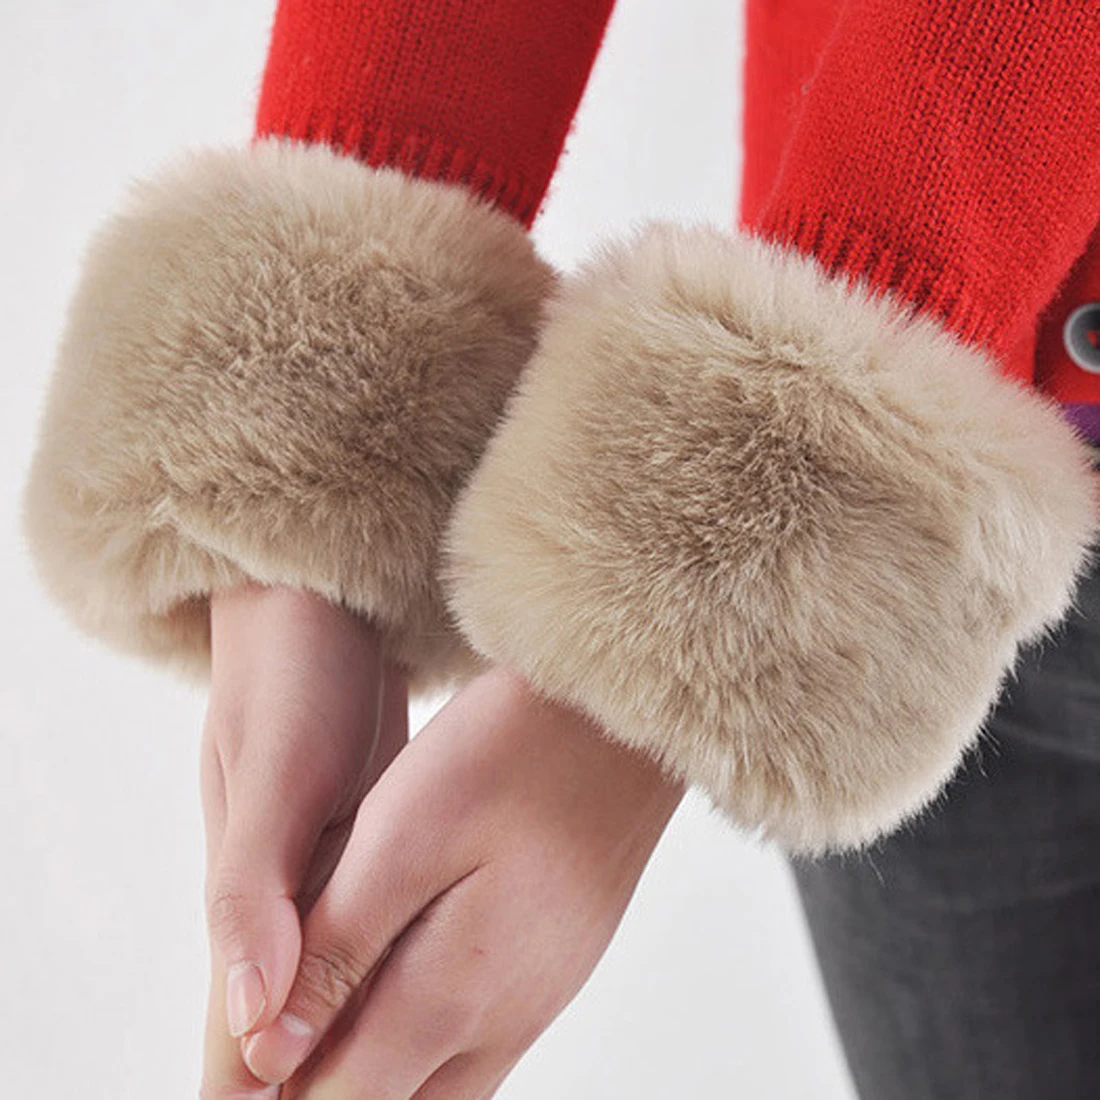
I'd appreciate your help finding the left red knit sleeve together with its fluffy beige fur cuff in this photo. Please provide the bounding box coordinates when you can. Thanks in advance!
[23,0,612,693]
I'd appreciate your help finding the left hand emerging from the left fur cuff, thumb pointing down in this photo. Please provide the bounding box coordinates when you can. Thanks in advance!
[201,584,407,1100]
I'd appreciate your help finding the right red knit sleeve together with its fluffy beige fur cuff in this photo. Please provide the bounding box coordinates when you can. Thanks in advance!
[444,0,1100,853]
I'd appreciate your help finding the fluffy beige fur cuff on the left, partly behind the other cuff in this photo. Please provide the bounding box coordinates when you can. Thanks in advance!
[23,141,553,689]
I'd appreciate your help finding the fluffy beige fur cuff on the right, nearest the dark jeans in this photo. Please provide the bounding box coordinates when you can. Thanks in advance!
[446,224,1093,853]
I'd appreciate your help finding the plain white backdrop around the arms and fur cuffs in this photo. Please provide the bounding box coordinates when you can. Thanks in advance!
[0,0,853,1100]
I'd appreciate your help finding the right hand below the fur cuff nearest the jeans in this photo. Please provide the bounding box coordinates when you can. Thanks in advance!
[244,669,682,1100]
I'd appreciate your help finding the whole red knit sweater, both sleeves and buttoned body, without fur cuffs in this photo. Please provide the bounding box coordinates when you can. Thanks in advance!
[256,0,1100,429]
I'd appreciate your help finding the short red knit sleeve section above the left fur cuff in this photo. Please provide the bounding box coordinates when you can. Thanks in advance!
[256,0,614,227]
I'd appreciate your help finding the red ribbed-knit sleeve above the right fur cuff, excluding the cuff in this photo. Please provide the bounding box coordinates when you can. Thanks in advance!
[751,0,1100,385]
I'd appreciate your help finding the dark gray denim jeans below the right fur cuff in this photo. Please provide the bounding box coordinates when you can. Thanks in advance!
[793,558,1100,1100]
